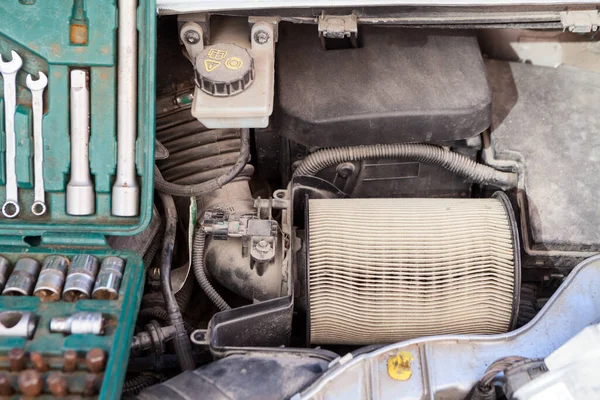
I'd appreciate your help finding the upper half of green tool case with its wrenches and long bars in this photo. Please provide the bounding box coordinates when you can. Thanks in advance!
[0,0,156,230]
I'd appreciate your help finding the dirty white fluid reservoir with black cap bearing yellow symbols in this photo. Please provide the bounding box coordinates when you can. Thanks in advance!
[181,22,276,129]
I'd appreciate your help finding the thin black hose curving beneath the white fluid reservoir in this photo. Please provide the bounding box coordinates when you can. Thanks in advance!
[154,129,250,197]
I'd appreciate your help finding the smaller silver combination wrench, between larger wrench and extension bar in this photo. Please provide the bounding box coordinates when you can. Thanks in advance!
[25,71,48,216]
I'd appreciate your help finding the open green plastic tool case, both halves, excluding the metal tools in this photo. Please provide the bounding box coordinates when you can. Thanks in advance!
[0,0,156,398]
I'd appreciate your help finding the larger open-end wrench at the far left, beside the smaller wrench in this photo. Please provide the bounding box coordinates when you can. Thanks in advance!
[0,50,23,218]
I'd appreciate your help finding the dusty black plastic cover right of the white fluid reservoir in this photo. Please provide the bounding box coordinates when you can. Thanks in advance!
[276,23,492,146]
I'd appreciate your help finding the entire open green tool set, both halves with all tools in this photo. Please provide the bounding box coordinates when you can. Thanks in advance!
[0,0,156,399]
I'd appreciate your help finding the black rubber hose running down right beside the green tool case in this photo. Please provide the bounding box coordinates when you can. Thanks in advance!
[159,193,195,371]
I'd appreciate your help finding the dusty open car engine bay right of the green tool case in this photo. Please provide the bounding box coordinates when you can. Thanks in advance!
[119,0,600,399]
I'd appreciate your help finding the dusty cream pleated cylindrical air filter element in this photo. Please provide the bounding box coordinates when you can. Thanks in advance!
[307,192,520,345]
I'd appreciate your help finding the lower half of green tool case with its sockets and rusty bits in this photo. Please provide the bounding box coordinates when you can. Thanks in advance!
[0,247,144,398]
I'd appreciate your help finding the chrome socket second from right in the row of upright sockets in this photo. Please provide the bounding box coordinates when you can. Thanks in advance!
[63,254,98,302]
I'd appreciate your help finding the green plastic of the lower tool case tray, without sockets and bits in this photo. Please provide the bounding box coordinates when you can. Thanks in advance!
[0,247,144,399]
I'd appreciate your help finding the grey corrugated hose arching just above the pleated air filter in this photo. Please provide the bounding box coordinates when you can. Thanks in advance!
[294,143,517,189]
